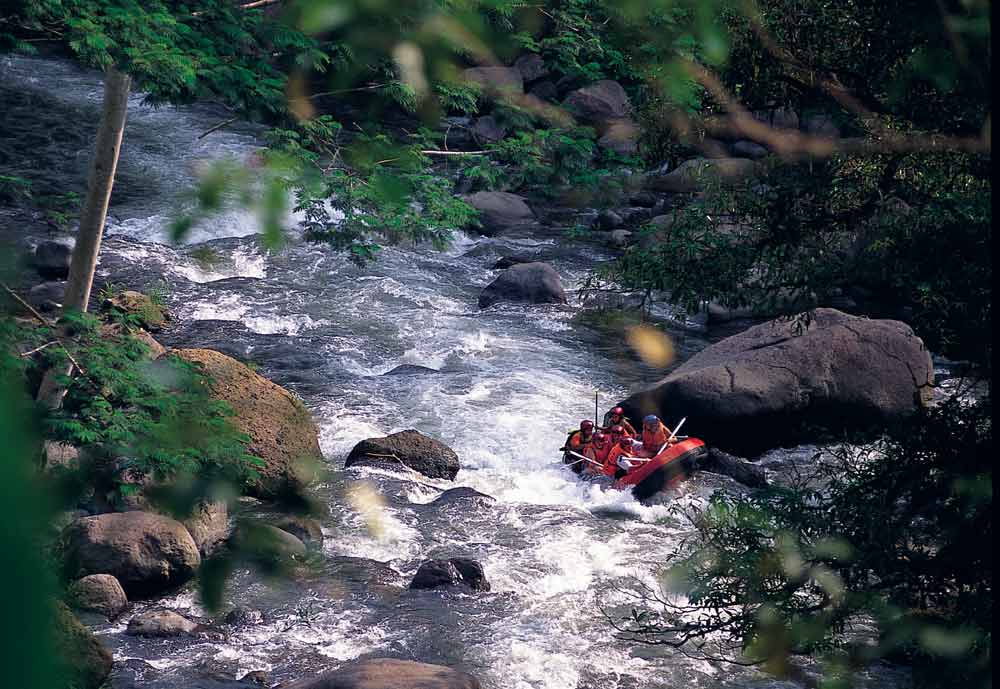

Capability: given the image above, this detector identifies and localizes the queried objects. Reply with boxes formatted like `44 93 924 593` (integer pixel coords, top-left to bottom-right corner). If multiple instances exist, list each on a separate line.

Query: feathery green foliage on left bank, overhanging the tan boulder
28 315 261 500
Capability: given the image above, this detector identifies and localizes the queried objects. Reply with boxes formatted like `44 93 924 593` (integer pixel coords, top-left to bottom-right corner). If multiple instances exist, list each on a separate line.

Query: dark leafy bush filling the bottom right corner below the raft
619 400 993 687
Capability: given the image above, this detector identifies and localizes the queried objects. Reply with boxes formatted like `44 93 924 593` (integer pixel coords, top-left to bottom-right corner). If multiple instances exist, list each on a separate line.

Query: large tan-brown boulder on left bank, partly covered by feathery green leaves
175 349 323 498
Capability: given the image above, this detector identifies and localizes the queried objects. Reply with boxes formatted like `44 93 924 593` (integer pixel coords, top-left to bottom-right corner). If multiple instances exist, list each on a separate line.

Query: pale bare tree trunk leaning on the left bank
38 67 130 409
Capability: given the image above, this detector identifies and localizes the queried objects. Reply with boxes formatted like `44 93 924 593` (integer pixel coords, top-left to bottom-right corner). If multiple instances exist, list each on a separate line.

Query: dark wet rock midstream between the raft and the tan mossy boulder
344 429 461 481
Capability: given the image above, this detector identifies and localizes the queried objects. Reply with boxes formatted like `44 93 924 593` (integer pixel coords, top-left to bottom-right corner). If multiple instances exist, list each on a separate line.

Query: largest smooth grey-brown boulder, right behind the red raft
622 308 934 456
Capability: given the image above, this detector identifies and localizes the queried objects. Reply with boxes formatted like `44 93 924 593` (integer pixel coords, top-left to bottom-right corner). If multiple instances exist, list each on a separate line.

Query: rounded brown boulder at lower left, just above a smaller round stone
61 512 201 596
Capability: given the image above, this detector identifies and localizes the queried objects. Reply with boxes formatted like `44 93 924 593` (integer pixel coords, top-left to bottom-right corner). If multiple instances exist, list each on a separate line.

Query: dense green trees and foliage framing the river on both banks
0 0 992 686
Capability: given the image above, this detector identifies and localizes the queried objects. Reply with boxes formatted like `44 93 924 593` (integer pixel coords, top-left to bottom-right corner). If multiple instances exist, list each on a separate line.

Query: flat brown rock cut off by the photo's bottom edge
281 658 481 689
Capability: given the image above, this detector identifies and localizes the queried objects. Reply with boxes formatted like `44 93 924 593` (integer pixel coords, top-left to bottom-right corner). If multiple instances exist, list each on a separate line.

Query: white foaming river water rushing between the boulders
0 58 901 689
